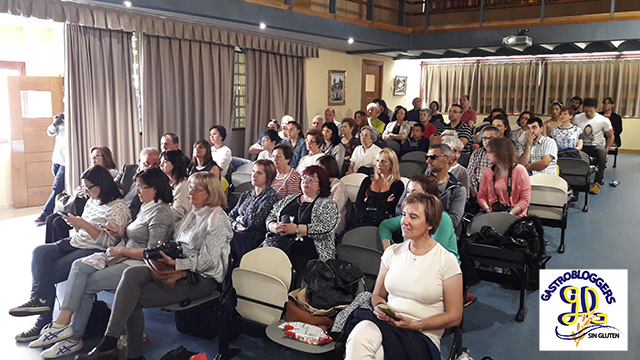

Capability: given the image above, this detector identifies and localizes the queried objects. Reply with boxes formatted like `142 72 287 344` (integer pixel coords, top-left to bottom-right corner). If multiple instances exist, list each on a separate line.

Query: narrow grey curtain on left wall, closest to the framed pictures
244 49 307 157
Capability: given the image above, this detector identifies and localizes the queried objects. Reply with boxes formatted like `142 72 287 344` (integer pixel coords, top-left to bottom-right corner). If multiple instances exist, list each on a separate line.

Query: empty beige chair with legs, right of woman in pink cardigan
528 174 569 254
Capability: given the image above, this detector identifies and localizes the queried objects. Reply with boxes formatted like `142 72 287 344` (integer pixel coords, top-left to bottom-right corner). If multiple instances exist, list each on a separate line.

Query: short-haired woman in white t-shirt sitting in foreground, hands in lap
345 194 463 360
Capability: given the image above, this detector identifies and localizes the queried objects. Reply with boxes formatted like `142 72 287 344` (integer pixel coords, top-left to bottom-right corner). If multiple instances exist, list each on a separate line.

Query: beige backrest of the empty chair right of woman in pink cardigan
527 184 567 220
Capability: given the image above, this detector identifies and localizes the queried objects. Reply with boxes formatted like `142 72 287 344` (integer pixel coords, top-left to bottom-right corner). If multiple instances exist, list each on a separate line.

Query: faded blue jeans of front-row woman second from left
60 259 134 338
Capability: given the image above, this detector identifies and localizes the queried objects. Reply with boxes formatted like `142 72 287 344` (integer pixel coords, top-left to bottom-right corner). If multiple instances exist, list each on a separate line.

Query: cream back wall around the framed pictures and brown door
305 49 420 127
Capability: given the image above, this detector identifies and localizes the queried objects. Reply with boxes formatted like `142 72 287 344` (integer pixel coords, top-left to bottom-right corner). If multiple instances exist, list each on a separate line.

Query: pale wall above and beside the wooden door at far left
0 19 64 209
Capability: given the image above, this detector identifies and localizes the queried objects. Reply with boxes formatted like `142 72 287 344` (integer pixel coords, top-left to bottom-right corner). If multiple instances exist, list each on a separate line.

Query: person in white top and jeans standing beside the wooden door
35 113 67 226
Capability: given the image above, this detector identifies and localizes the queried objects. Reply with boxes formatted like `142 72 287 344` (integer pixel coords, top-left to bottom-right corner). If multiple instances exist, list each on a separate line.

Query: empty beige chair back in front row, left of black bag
232 247 291 325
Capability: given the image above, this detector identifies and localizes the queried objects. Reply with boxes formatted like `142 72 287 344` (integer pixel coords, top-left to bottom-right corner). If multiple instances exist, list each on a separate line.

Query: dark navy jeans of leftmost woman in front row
31 239 100 328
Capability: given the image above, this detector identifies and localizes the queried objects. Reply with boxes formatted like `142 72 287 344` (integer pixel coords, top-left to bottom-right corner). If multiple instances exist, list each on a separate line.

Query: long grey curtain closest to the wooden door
65 24 140 188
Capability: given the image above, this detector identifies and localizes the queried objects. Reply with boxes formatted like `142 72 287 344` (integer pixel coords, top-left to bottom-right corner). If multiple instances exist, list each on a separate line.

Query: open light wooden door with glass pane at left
7 76 64 208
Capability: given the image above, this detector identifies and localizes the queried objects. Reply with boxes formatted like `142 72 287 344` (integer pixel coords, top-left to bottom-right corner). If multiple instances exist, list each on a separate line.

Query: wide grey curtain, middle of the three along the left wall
142 36 234 151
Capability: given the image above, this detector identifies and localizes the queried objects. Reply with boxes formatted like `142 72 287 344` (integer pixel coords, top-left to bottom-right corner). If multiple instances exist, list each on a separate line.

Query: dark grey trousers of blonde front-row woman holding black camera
105 266 218 358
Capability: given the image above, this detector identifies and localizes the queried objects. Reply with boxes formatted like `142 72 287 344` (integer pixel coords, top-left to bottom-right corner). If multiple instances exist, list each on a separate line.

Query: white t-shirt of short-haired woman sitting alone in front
382 241 462 349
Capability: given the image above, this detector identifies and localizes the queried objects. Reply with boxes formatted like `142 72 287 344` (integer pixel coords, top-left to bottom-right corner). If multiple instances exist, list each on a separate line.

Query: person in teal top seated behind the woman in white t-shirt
378 174 460 262
